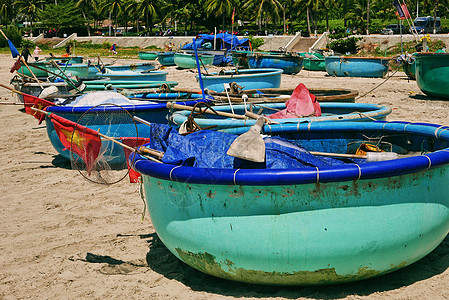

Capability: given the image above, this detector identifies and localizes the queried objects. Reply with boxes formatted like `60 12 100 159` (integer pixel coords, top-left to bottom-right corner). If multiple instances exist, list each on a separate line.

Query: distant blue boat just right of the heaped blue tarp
247 52 304 74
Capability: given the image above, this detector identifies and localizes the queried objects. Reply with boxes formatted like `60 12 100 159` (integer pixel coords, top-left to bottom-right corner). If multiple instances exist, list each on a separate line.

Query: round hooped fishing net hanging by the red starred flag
70 103 139 185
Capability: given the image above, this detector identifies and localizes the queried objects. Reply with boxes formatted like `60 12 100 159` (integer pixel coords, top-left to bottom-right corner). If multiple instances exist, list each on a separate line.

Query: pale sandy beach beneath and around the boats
0 55 449 299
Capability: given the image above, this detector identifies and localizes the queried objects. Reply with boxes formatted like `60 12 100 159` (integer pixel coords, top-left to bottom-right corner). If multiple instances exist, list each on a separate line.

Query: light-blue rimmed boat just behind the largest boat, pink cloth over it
170 103 392 130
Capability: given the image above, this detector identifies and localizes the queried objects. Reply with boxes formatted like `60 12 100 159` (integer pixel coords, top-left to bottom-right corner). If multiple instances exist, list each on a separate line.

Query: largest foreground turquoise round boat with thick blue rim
133 122 449 285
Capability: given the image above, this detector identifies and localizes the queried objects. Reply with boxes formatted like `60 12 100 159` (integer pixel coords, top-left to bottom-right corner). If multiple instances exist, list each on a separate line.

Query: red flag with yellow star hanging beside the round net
49 114 101 174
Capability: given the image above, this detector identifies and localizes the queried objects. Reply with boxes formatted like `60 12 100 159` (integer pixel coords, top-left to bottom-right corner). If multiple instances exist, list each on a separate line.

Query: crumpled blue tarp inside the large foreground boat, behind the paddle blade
147 123 360 169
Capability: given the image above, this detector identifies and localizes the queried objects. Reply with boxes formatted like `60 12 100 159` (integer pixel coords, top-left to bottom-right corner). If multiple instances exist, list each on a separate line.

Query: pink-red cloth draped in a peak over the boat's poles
268 83 321 119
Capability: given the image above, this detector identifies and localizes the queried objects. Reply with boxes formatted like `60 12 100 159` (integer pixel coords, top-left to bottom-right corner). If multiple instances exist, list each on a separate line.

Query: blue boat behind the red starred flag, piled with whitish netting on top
46 98 207 165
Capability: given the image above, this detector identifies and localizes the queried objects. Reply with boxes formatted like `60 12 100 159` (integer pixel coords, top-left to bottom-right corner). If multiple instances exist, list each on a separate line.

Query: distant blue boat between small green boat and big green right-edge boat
325 56 389 78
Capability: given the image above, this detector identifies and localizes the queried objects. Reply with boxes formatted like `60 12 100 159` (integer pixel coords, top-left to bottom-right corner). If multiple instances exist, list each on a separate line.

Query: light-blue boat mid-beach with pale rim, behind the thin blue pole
196 69 283 93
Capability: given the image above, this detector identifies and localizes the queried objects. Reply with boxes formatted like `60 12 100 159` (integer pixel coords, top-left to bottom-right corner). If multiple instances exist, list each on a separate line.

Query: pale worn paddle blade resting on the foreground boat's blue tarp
226 118 265 163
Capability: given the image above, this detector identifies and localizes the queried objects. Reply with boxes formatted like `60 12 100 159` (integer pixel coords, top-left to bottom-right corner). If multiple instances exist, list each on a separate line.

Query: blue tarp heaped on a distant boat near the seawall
182 33 249 50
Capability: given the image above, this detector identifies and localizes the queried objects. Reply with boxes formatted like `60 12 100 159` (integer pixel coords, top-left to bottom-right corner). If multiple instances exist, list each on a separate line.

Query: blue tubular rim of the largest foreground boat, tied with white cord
129 121 449 186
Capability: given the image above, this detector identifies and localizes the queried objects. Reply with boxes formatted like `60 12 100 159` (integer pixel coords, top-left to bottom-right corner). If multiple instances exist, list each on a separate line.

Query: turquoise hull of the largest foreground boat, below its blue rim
143 167 449 285
